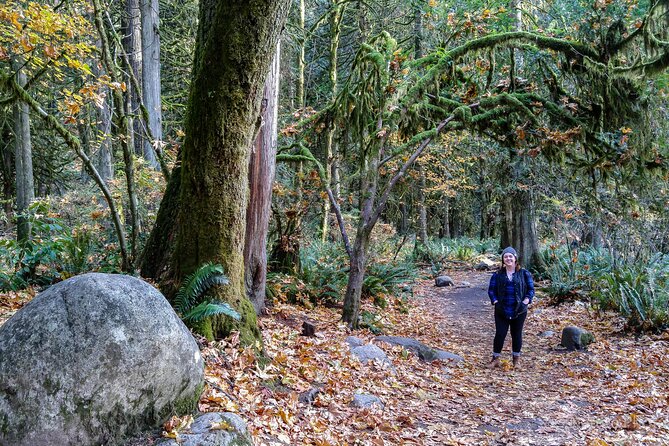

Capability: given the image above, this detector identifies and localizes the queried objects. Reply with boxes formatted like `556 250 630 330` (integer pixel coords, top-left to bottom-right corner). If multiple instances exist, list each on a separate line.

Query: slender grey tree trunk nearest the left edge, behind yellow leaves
14 64 35 242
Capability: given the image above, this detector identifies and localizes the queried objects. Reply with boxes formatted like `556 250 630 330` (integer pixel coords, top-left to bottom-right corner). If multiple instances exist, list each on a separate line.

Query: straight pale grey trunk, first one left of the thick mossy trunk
140 0 163 170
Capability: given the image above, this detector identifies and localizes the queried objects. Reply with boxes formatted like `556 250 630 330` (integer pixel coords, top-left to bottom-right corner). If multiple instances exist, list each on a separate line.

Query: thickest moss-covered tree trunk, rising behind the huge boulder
144 0 290 345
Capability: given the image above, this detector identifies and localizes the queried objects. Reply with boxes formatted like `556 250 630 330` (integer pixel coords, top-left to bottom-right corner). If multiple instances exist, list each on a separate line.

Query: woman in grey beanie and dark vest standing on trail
488 246 534 367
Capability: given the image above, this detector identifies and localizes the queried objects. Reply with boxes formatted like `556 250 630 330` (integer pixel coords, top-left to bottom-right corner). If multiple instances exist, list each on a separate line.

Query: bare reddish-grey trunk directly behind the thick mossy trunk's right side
244 42 281 314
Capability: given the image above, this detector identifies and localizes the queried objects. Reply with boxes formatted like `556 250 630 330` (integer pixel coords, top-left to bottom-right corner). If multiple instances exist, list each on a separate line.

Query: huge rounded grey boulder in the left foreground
0 274 204 446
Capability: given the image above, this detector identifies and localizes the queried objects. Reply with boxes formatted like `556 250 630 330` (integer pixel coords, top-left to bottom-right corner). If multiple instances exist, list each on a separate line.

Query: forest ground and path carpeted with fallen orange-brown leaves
0 270 669 446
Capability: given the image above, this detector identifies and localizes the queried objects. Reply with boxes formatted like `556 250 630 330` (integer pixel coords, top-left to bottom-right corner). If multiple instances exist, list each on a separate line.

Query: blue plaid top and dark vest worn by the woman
488 269 534 319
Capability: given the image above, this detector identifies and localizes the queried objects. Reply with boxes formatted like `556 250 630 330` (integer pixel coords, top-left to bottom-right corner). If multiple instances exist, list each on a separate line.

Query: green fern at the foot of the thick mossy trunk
174 263 241 322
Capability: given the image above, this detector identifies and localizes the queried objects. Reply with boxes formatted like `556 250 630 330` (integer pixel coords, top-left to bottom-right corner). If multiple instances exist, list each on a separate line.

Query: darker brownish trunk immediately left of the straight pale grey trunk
122 0 144 159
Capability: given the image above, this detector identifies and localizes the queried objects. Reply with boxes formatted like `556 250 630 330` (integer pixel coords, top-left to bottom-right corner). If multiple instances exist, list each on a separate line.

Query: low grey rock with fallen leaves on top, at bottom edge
156 412 253 446
